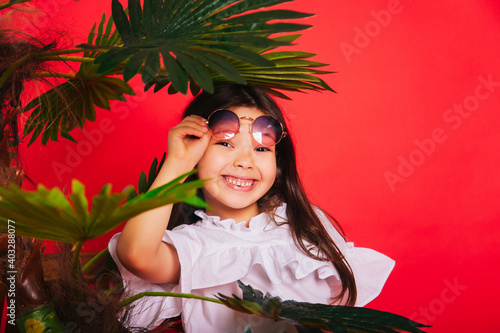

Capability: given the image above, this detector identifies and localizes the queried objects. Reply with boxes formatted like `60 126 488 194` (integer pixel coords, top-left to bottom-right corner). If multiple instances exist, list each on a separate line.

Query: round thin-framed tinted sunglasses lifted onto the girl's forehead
205 110 286 146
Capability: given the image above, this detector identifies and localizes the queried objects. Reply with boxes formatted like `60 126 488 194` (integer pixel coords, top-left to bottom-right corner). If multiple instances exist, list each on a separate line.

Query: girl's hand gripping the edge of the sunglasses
166 115 211 173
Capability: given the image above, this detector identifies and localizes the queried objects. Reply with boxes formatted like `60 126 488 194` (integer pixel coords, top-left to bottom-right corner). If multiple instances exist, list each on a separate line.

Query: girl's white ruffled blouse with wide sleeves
109 204 395 333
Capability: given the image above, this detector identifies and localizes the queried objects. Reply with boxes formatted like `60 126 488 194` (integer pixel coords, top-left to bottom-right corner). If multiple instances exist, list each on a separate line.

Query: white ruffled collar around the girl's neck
195 203 288 232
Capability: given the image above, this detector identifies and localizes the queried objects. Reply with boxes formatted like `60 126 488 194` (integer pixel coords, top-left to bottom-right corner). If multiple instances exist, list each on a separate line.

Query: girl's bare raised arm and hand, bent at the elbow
116 116 212 283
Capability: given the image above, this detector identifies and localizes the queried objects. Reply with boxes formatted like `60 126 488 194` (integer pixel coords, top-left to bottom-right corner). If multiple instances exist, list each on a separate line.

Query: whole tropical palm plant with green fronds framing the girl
0 0 430 332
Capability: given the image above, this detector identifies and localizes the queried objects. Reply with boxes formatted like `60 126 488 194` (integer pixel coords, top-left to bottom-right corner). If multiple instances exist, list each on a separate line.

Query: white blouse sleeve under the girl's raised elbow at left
108 233 182 328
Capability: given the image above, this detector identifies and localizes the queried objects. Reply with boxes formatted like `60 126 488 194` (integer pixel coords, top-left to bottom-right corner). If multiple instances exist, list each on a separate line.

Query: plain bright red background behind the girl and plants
13 0 500 332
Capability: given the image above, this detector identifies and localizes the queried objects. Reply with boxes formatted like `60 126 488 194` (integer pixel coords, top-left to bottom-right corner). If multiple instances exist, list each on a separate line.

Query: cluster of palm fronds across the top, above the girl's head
0 0 332 148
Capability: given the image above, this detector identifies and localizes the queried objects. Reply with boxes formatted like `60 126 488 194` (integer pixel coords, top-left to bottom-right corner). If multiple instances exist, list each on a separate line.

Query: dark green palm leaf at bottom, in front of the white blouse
217 281 428 333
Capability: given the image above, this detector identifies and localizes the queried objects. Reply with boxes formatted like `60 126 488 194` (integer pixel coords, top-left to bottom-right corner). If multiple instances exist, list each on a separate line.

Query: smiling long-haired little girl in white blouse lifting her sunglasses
109 84 394 333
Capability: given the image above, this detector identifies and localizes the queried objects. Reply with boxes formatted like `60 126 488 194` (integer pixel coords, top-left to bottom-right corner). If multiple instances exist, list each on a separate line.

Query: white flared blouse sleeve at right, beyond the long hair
316 208 395 306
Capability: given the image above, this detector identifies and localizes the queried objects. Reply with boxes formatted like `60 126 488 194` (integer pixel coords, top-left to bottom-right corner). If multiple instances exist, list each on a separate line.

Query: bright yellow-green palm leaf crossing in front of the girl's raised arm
0 173 205 243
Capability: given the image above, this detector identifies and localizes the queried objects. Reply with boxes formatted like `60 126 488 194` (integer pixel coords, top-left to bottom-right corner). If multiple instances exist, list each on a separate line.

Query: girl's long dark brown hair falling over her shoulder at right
168 84 357 305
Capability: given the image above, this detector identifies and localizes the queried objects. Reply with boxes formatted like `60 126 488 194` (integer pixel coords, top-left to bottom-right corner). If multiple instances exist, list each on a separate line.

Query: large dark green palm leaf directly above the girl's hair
95 0 310 94
